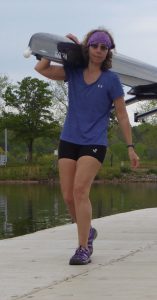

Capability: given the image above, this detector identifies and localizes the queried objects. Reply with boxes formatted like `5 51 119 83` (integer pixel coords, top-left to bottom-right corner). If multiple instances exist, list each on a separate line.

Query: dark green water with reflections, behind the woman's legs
0 183 157 239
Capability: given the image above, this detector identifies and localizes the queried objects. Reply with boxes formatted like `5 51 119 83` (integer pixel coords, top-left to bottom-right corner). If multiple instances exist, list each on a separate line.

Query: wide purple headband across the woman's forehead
87 31 112 49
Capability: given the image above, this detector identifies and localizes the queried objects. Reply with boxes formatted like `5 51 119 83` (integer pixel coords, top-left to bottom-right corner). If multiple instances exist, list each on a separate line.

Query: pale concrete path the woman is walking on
0 208 157 300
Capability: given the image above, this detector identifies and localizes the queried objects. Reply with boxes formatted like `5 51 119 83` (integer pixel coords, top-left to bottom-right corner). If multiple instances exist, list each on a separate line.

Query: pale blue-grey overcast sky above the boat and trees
0 0 157 124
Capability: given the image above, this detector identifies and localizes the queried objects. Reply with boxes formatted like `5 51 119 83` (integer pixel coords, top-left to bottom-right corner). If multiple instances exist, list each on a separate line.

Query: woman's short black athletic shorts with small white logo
58 140 107 163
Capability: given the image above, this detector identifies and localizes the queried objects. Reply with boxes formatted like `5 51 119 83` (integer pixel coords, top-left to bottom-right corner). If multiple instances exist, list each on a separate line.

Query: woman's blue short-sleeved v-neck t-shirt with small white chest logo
61 68 124 146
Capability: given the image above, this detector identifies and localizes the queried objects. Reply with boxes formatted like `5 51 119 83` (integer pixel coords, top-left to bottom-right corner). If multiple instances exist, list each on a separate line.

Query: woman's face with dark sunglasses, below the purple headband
89 44 108 65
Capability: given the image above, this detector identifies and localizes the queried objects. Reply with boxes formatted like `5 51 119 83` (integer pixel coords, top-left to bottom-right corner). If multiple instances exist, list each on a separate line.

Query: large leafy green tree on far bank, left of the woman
0 77 60 162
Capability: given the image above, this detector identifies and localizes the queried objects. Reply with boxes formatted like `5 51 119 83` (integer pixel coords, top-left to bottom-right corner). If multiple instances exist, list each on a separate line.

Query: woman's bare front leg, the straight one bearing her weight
73 156 101 248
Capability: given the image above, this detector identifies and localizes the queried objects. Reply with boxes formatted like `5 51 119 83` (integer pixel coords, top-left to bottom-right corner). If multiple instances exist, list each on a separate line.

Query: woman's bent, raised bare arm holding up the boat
34 58 65 80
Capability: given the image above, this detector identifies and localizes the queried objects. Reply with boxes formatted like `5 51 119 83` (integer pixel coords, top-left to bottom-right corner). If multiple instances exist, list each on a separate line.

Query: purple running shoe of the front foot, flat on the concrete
69 246 91 265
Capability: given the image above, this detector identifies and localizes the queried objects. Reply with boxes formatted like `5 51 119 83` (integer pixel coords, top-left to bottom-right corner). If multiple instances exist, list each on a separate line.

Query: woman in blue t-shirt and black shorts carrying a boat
35 29 139 265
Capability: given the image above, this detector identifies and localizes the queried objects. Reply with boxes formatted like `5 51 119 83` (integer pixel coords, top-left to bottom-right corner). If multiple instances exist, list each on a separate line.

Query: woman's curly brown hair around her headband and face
82 29 115 71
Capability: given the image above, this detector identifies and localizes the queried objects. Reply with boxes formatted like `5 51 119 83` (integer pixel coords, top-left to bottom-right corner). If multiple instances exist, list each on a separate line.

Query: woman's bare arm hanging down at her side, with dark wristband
114 97 139 168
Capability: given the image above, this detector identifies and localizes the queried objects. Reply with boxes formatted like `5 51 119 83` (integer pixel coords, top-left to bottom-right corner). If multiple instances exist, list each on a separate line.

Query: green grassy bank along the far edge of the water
0 162 157 181
